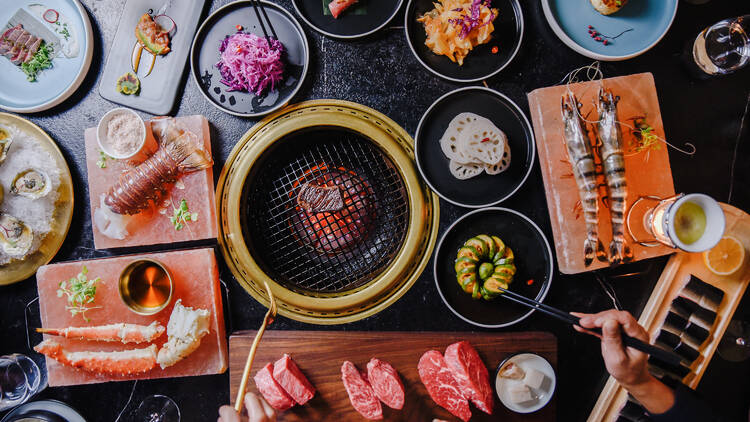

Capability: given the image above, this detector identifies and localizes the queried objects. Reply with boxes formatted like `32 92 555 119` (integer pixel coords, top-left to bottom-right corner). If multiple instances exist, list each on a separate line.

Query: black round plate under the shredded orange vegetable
404 0 524 82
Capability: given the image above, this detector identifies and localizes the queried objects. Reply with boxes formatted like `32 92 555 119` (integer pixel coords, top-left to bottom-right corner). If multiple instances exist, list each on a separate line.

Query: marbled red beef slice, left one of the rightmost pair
417 350 471 421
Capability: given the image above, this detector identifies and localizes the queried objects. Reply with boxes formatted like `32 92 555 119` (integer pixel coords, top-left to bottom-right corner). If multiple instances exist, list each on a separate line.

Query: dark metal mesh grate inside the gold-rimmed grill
244 129 409 294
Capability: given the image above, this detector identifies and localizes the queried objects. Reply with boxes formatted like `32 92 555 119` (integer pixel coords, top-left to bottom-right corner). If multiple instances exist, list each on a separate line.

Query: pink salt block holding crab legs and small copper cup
37 248 227 387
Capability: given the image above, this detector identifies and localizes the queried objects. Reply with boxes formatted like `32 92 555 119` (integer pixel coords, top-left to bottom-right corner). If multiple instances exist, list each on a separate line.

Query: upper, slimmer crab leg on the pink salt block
36 321 165 344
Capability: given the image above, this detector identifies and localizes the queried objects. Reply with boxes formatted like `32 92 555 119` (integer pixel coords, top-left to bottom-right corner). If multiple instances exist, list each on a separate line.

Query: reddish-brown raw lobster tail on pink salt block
104 118 213 215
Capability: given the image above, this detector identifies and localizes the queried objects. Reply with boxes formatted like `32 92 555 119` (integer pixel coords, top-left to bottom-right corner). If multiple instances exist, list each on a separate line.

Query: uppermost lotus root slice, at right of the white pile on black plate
459 115 508 164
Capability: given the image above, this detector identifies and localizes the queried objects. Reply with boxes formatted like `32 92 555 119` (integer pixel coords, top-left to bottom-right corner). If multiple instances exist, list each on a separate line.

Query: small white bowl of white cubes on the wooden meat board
495 353 557 413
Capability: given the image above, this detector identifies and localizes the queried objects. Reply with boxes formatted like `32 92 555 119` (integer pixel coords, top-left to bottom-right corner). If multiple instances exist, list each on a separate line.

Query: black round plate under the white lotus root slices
414 87 536 208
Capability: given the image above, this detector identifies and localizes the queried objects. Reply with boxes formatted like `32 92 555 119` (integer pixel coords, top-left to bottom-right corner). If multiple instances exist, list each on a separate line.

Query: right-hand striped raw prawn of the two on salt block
597 88 633 264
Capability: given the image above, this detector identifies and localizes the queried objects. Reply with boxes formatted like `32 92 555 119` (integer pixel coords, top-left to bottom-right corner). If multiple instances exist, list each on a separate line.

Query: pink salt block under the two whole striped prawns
528 73 677 274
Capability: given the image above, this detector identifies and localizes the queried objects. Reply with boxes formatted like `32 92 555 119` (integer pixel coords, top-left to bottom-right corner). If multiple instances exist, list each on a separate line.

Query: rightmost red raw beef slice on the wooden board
445 341 495 415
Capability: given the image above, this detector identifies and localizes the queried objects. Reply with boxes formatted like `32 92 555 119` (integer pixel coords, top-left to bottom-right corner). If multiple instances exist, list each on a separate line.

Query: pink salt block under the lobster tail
84 115 219 249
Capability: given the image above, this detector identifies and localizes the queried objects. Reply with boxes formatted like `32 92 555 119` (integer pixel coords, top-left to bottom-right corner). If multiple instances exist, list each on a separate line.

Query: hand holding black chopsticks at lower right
573 309 652 389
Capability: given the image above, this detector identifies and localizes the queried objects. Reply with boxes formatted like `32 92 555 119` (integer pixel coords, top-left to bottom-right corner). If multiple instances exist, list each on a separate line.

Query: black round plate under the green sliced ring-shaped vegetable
434 208 552 328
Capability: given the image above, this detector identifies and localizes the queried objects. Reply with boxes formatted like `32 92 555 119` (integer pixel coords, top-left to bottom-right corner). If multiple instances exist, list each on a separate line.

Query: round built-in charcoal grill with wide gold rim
216 100 439 324
